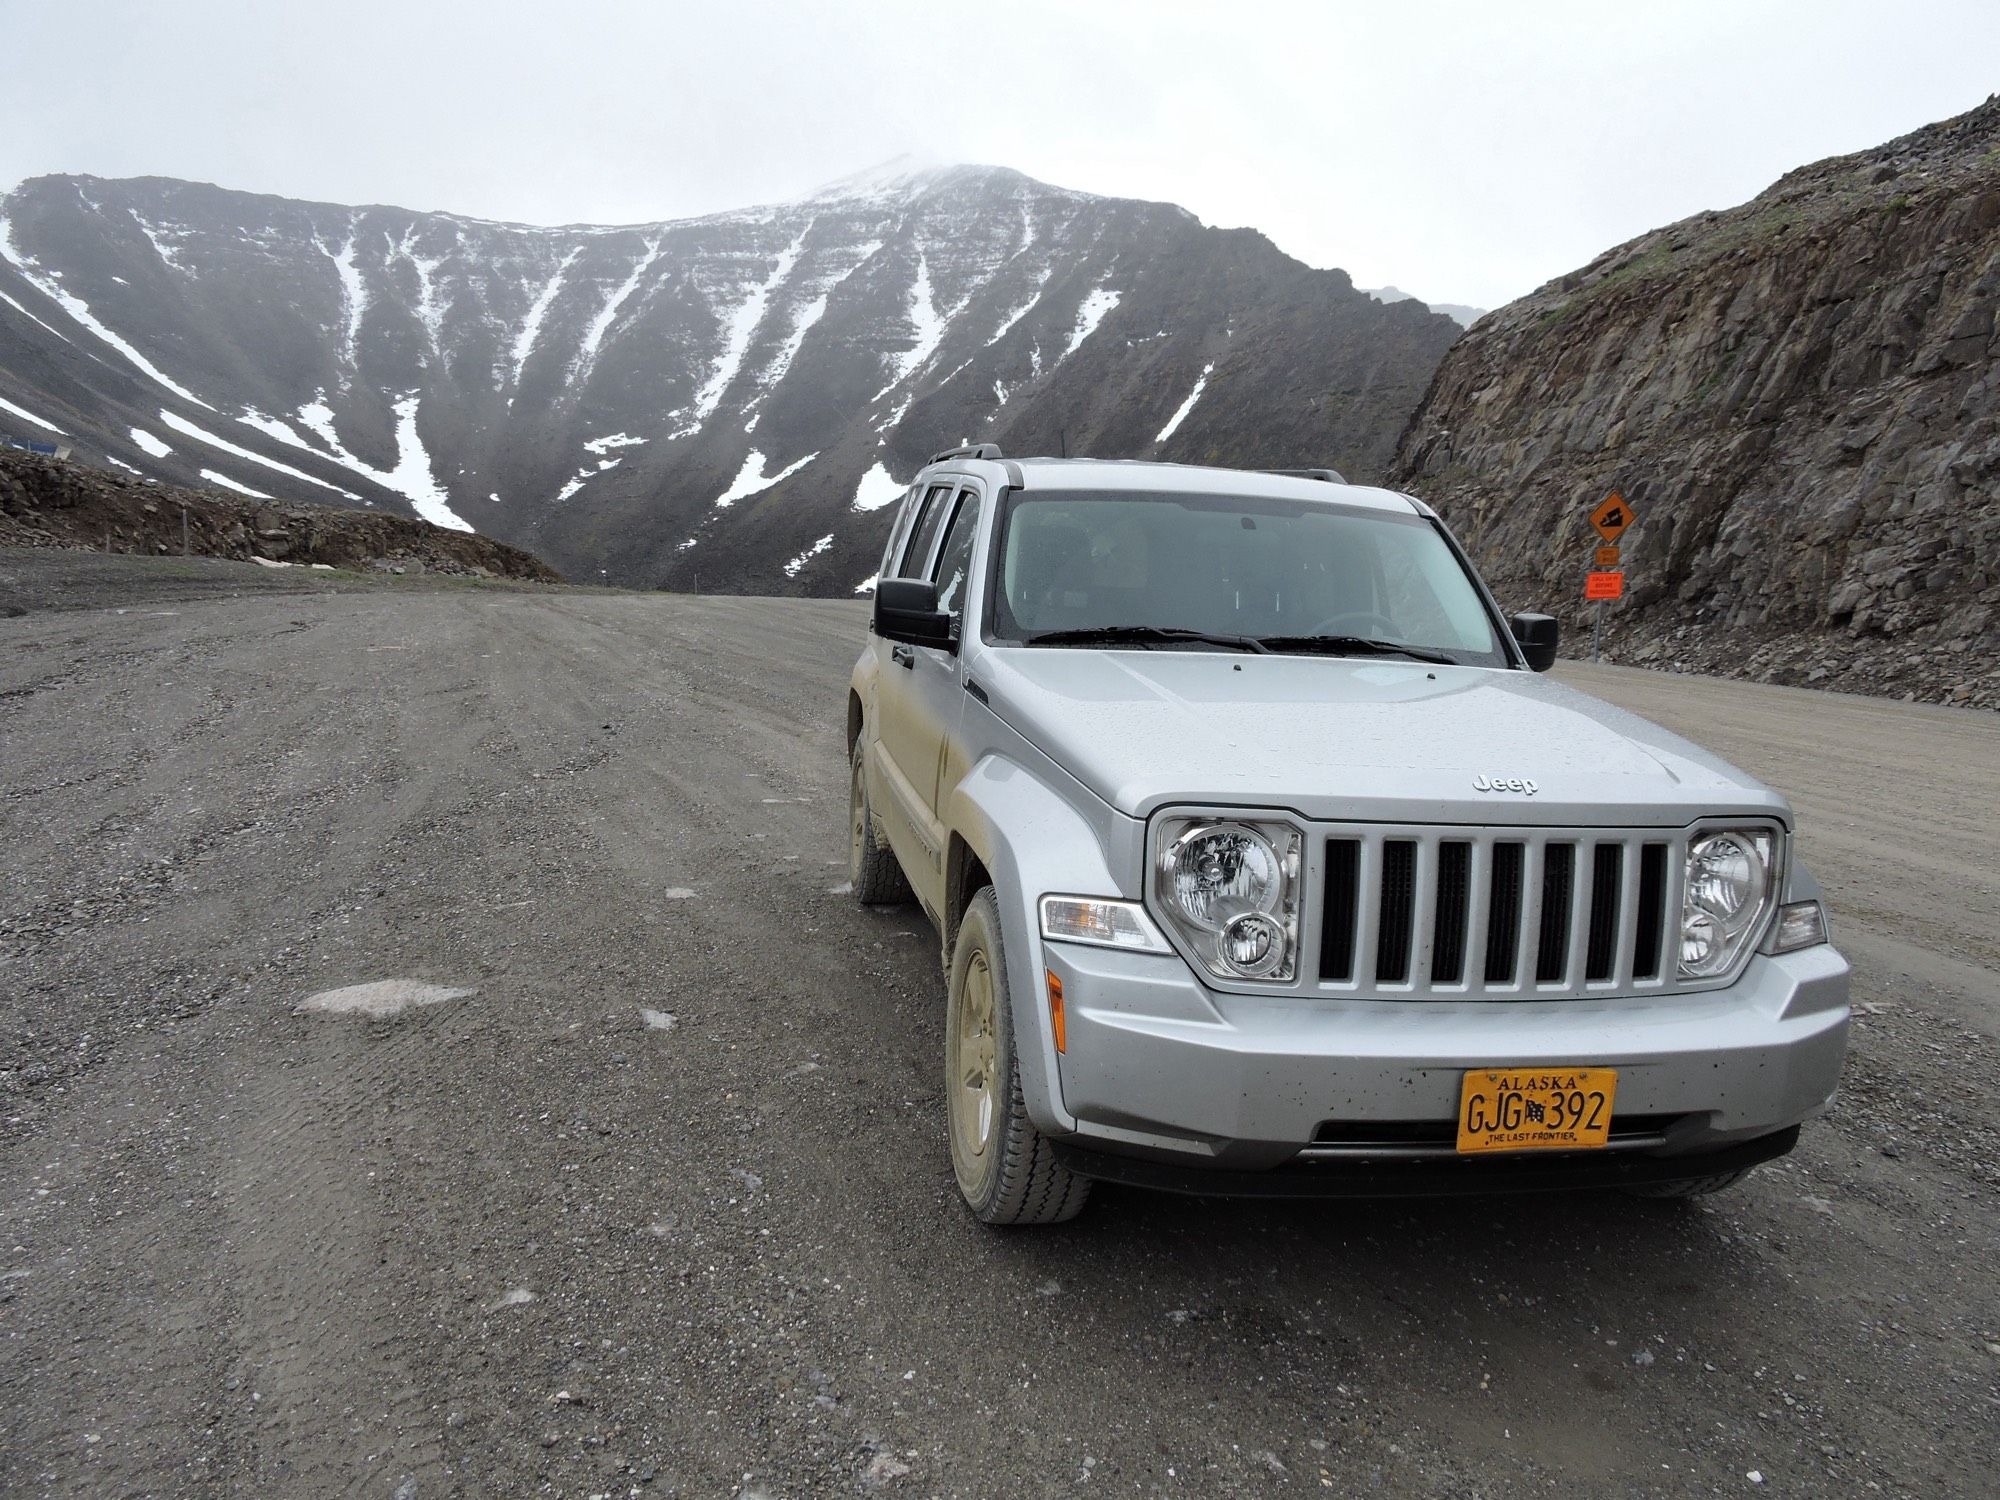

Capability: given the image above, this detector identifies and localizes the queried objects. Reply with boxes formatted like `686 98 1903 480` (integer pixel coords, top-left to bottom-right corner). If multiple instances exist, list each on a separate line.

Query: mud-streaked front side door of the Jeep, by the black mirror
876 482 980 910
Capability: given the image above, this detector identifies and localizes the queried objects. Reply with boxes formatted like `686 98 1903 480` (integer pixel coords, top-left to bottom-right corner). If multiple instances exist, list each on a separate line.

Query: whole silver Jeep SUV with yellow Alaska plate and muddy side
848 444 1848 1224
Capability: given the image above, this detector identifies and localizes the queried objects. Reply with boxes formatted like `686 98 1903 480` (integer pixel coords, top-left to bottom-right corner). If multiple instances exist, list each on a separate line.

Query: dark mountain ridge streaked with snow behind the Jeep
0 164 1458 594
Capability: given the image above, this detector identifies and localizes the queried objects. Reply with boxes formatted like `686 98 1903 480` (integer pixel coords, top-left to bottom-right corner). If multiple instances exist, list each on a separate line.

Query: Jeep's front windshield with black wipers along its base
994 490 1508 666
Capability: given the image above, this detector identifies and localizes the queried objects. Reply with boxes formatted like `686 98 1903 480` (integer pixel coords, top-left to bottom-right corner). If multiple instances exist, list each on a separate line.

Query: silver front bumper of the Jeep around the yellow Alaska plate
1042 944 1848 1192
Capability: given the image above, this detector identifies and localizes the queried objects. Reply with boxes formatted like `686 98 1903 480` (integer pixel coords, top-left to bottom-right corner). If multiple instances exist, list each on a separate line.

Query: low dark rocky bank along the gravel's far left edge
0 448 560 582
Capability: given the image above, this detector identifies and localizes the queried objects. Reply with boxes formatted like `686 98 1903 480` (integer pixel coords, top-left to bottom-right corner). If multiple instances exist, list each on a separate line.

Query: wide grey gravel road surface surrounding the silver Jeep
0 552 2000 1500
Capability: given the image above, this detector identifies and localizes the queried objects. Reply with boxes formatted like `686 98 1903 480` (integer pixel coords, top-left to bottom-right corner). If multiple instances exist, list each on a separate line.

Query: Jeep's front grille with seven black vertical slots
1316 826 1678 998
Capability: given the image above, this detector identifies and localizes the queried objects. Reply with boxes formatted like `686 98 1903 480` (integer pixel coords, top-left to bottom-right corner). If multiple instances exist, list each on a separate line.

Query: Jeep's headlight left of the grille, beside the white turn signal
1154 818 1304 980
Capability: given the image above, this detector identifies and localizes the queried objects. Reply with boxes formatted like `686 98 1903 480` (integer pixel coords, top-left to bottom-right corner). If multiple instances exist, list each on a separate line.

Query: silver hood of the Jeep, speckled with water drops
976 648 1790 826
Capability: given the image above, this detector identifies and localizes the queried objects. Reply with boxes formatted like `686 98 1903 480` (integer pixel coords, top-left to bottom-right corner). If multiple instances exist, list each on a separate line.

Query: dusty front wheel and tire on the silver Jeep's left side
944 886 1090 1224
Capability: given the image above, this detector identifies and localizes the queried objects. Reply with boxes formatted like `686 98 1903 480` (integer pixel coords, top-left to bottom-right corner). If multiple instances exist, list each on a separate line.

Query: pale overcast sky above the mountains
0 0 2000 306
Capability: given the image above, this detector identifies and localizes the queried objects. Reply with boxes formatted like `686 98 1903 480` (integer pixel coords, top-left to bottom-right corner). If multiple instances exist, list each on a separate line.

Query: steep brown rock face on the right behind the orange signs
1390 100 2000 708
